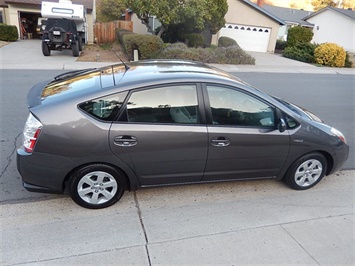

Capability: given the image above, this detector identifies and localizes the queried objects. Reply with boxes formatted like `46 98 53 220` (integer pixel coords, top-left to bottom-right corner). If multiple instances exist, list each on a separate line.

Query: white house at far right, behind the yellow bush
304 6 355 53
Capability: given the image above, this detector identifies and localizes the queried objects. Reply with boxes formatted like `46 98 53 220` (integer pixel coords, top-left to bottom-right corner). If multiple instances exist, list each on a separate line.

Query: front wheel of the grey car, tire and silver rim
285 153 327 190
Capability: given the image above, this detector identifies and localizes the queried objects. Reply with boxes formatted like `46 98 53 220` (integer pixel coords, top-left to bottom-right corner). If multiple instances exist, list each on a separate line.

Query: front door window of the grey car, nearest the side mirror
207 85 276 127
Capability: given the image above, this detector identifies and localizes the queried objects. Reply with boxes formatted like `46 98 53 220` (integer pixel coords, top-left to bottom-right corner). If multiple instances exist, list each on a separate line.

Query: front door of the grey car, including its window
203 84 289 181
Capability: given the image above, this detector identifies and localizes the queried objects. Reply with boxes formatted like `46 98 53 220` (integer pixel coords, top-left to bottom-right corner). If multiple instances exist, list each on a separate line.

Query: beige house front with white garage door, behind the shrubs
212 0 286 53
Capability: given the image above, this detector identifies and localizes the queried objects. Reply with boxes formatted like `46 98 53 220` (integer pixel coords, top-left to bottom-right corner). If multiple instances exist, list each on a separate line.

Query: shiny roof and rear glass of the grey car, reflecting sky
36 60 251 106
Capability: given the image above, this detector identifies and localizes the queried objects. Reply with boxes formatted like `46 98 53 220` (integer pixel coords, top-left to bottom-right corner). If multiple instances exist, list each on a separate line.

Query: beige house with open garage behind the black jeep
0 0 96 44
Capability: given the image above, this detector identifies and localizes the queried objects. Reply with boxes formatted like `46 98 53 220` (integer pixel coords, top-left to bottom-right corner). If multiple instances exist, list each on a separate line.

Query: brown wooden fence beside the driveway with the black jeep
94 20 133 44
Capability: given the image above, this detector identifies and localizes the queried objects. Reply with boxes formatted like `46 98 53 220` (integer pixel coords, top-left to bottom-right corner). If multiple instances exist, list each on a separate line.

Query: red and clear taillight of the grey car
23 113 43 153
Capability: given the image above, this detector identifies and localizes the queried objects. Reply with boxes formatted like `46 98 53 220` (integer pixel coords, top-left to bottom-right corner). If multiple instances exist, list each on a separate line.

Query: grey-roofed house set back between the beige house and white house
262 5 314 41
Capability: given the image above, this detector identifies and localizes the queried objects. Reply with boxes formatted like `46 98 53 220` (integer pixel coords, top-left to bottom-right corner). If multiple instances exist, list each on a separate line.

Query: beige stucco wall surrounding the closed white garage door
212 0 280 53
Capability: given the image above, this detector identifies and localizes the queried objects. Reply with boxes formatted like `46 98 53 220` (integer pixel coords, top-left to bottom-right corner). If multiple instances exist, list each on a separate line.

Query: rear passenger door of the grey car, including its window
109 84 207 186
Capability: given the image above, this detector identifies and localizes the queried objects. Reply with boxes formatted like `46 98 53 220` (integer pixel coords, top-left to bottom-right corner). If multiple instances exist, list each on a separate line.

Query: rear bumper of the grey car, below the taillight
17 149 77 193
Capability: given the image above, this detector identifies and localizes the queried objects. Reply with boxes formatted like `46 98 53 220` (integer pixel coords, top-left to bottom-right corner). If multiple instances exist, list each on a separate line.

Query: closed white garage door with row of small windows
219 24 271 52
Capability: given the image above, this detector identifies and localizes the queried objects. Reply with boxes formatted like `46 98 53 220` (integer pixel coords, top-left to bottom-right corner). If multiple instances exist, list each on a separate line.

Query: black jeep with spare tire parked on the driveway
42 18 82 57
